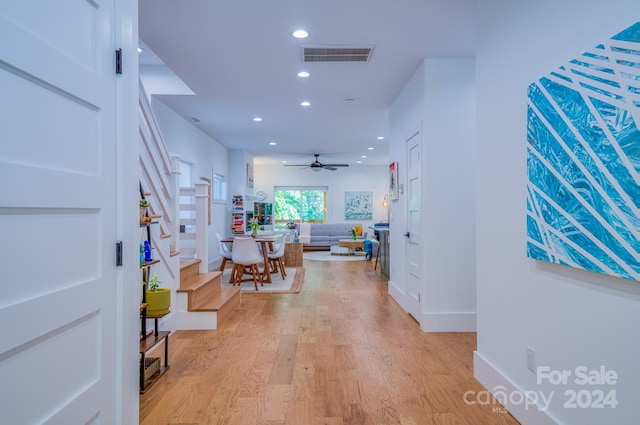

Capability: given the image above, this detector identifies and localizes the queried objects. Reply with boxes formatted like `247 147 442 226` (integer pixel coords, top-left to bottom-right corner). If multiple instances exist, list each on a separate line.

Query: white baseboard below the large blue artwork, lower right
476 351 559 425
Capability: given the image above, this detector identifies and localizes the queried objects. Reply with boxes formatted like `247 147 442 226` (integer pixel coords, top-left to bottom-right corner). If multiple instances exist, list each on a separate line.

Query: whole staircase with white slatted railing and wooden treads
139 83 240 331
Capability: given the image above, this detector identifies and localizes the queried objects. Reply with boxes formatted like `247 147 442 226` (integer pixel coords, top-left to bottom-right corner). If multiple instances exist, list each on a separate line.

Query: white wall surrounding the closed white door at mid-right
389 58 476 331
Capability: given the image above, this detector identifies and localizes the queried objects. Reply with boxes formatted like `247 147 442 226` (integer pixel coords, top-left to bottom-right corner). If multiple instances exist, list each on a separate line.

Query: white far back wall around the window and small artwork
254 164 388 230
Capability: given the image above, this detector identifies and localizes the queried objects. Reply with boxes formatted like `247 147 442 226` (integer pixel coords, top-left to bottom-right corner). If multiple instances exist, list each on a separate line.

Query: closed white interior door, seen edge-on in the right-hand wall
405 130 423 322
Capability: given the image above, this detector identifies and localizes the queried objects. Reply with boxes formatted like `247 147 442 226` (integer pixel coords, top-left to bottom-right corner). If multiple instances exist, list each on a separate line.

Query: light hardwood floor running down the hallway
140 261 518 425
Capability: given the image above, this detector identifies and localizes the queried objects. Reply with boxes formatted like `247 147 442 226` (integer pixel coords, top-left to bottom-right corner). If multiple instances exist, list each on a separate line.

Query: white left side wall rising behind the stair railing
151 97 229 268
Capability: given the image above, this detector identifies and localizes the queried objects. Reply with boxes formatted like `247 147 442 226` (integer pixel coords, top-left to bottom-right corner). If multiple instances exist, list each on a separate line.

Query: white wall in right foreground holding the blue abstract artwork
475 0 640 424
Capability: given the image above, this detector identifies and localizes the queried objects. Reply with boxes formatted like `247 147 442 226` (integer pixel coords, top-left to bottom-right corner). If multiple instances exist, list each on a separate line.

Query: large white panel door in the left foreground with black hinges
0 0 117 425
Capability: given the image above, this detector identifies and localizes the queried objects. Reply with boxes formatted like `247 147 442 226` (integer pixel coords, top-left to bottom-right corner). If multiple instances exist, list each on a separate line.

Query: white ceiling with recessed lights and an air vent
139 0 475 165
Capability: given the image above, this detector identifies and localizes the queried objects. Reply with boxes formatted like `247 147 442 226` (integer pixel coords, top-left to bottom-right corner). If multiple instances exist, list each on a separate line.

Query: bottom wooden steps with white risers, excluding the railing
177 259 240 330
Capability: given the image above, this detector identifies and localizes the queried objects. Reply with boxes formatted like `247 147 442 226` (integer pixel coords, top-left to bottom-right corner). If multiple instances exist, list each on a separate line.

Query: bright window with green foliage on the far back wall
273 186 327 229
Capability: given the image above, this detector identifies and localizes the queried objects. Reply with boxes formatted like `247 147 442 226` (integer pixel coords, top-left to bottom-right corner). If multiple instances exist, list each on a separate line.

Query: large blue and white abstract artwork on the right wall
527 22 640 281
